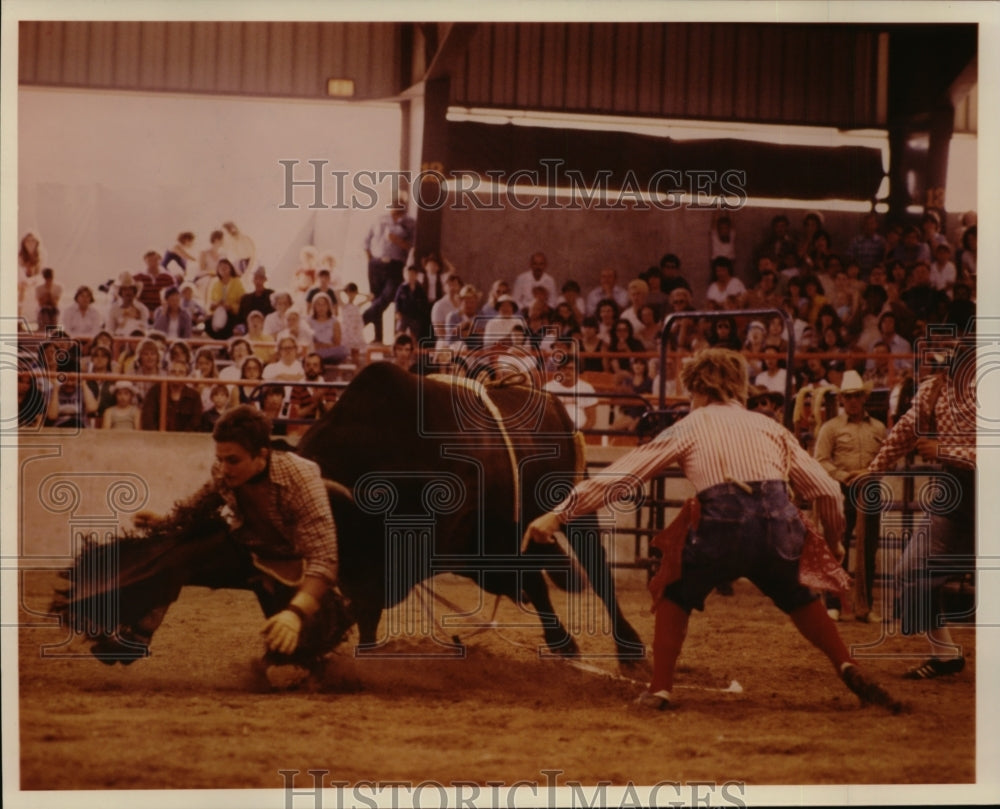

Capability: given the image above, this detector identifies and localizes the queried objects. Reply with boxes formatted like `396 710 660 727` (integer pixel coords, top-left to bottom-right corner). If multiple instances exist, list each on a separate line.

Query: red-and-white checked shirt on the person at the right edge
868 374 976 472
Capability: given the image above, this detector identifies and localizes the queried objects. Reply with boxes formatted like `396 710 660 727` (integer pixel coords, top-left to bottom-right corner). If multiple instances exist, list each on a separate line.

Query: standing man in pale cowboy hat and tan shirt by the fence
813 369 886 623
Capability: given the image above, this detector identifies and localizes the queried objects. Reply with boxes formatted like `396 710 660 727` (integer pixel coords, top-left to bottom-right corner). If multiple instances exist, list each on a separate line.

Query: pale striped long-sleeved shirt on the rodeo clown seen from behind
555 402 843 531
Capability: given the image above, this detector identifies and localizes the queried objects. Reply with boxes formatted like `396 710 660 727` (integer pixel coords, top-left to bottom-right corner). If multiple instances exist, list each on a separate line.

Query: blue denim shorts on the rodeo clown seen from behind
663 480 816 613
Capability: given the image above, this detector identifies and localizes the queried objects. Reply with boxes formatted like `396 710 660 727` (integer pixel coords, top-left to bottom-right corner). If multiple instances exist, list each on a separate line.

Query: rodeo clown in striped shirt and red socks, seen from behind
525 348 903 713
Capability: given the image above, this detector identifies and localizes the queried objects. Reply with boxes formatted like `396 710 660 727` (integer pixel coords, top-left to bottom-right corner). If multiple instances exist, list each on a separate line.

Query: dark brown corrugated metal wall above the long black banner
452 23 885 127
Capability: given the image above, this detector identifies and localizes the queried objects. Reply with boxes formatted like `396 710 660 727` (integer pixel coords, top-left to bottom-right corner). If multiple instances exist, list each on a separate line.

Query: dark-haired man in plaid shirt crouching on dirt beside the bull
74 405 349 688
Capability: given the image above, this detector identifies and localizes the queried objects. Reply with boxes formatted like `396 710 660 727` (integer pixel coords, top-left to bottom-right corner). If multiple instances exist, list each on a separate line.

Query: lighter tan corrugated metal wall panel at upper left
19 22 402 98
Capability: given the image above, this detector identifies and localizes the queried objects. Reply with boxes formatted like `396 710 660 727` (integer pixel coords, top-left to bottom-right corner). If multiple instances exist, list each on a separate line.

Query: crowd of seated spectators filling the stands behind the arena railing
18 204 976 443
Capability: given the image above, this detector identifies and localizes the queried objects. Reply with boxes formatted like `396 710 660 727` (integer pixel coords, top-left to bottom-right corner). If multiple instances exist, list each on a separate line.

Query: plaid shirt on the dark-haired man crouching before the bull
213 452 337 583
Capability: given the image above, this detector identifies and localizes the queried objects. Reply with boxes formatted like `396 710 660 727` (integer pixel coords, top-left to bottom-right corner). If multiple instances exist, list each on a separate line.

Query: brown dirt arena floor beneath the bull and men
13 571 976 790
